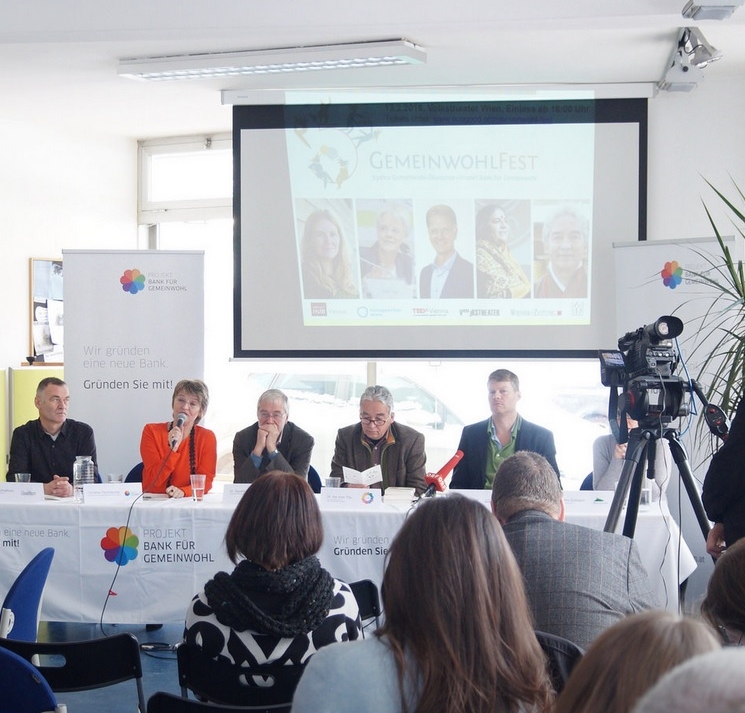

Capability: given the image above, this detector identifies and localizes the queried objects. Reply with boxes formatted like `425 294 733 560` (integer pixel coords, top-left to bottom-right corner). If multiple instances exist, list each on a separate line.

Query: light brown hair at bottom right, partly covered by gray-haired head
555 610 719 713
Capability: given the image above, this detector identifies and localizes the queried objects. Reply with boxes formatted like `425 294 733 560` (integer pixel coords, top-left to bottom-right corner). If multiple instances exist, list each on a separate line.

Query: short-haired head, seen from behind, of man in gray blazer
491 451 561 522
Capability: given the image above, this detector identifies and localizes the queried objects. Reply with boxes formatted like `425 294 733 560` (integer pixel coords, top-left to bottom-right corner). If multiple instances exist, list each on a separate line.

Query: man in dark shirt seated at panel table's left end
7 376 100 497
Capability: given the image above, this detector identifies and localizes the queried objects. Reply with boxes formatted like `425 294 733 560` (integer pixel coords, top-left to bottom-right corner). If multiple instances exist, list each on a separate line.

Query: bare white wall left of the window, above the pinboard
0 119 137 368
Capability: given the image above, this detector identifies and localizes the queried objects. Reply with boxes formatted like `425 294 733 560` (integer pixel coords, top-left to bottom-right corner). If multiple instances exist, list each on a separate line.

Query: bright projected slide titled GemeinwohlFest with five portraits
286 124 595 326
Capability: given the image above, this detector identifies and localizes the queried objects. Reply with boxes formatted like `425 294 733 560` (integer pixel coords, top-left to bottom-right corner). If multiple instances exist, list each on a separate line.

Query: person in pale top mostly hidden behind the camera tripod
592 415 673 500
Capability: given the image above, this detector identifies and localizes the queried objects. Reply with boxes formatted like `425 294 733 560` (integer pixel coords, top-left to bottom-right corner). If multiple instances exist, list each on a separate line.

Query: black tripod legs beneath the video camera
604 425 711 540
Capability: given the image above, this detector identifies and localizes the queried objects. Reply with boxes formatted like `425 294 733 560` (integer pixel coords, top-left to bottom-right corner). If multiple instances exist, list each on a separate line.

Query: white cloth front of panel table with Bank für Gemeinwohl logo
0 492 696 624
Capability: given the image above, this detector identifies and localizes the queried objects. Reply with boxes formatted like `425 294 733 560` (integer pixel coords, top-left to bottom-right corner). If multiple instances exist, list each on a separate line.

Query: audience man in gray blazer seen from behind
492 451 658 649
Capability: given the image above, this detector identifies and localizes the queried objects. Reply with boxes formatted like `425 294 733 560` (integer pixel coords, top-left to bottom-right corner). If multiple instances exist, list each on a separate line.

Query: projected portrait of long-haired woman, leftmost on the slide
300 210 359 300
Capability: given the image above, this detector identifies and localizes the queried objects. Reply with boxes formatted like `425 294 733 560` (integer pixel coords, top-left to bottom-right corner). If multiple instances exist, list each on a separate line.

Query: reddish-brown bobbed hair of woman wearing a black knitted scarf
225 470 323 570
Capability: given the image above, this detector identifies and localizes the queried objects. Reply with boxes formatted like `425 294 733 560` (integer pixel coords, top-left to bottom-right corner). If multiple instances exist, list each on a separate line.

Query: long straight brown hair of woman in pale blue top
377 495 552 713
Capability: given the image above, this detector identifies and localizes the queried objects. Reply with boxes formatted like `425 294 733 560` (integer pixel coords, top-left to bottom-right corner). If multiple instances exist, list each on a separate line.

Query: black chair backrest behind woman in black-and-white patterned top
176 642 305 711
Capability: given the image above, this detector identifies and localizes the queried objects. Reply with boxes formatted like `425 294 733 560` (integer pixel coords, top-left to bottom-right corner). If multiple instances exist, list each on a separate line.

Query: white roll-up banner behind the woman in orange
63 250 204 479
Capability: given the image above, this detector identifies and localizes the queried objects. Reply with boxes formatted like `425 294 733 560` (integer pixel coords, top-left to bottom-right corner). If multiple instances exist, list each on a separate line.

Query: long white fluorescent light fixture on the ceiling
118 39 427 81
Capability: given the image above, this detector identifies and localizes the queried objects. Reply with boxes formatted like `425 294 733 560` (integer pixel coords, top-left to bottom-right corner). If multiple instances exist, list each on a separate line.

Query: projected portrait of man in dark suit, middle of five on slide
419 205 473 299
